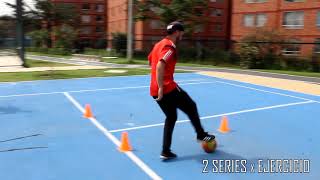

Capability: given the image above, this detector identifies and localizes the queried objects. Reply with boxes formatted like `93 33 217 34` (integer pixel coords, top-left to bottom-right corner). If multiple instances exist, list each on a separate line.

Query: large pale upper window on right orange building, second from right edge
283 11 304 29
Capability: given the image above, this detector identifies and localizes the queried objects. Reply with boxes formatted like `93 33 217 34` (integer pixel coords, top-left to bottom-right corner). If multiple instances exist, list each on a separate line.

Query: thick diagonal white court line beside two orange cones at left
63 92 162 179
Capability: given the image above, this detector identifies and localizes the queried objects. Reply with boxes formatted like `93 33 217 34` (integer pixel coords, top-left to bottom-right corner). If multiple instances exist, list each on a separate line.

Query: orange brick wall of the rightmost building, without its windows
231 0 320 56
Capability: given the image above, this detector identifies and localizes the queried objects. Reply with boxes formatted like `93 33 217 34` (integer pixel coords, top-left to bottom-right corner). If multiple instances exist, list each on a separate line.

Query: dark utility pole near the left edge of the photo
16 0 25 65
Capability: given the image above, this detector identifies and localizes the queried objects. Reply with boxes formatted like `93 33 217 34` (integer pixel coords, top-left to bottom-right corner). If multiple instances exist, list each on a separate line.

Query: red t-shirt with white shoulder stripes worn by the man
148 38 177 96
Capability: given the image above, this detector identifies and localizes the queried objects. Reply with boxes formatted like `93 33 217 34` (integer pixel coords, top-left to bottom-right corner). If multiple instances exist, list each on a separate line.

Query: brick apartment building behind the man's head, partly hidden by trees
107 0 230 49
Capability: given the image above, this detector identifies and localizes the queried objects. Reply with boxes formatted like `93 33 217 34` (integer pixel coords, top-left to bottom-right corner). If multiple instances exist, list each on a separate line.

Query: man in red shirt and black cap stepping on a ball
148 21 215 159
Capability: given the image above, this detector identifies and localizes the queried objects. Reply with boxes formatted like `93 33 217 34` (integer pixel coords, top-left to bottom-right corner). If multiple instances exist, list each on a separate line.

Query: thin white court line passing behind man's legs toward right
109 100 315 133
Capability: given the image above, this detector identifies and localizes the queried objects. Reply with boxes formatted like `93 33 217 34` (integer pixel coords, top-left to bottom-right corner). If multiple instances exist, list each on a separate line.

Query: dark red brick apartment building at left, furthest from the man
52 0 107 47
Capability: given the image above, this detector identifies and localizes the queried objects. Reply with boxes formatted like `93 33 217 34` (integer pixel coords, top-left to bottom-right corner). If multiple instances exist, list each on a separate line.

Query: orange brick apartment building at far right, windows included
231 0 320 56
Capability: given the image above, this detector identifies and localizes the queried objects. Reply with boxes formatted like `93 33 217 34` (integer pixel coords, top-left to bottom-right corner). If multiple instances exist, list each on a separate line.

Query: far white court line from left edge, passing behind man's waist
0 81 216 98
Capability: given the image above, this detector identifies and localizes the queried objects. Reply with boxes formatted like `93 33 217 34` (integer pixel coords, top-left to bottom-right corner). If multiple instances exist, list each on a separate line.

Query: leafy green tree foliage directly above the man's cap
135 0 209 33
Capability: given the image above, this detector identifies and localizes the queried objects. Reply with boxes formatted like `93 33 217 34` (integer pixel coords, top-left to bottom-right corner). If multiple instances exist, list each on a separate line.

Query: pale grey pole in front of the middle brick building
127 0 133 61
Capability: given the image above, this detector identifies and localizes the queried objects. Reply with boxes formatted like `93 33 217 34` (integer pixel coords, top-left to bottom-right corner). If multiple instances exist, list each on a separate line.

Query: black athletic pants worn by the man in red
153 87 204 152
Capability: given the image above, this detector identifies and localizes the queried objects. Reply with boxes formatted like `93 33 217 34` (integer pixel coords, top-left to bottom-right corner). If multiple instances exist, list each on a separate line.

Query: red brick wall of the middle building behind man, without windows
106 0 230 49
